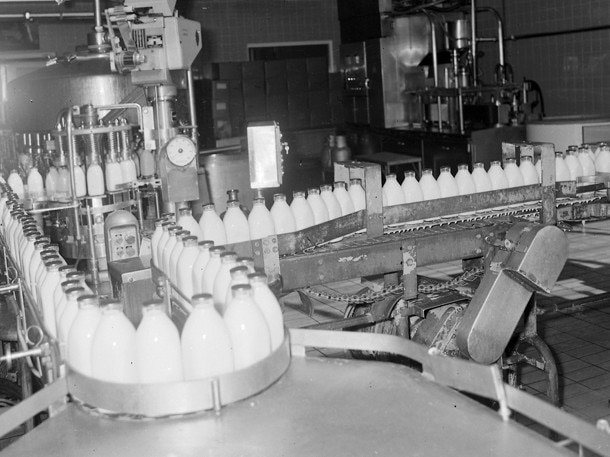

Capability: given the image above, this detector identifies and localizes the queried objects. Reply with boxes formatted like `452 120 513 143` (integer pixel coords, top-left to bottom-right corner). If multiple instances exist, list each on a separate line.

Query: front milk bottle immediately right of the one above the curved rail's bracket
224 285 271 370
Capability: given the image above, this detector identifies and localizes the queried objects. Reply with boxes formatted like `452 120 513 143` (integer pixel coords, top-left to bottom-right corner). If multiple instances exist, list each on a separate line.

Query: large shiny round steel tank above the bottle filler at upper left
7 58 136 131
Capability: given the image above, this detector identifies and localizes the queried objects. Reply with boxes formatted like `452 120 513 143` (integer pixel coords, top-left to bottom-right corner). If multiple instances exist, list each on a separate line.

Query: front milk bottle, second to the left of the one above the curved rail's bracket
91 302 138 384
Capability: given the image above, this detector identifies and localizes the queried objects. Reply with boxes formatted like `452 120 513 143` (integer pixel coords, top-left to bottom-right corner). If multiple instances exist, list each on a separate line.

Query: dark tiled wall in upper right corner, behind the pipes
479 0 610 116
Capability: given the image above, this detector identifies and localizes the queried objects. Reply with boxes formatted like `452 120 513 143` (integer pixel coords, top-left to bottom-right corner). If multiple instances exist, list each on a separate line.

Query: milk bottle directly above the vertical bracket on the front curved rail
181 294 233 381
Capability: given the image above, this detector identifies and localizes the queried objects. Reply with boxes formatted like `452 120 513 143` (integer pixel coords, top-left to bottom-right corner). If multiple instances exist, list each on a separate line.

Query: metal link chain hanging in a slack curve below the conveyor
300 268 484 305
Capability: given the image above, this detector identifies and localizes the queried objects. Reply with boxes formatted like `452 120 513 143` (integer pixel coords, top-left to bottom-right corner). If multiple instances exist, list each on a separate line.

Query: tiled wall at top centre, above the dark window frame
183 0 340 67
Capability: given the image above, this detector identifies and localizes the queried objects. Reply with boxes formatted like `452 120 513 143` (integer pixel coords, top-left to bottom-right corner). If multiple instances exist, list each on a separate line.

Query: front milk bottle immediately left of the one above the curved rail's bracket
136 300 183 383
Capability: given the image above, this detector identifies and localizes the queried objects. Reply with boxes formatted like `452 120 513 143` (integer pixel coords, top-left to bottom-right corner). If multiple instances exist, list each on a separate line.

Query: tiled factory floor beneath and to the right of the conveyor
284 221 610 432
